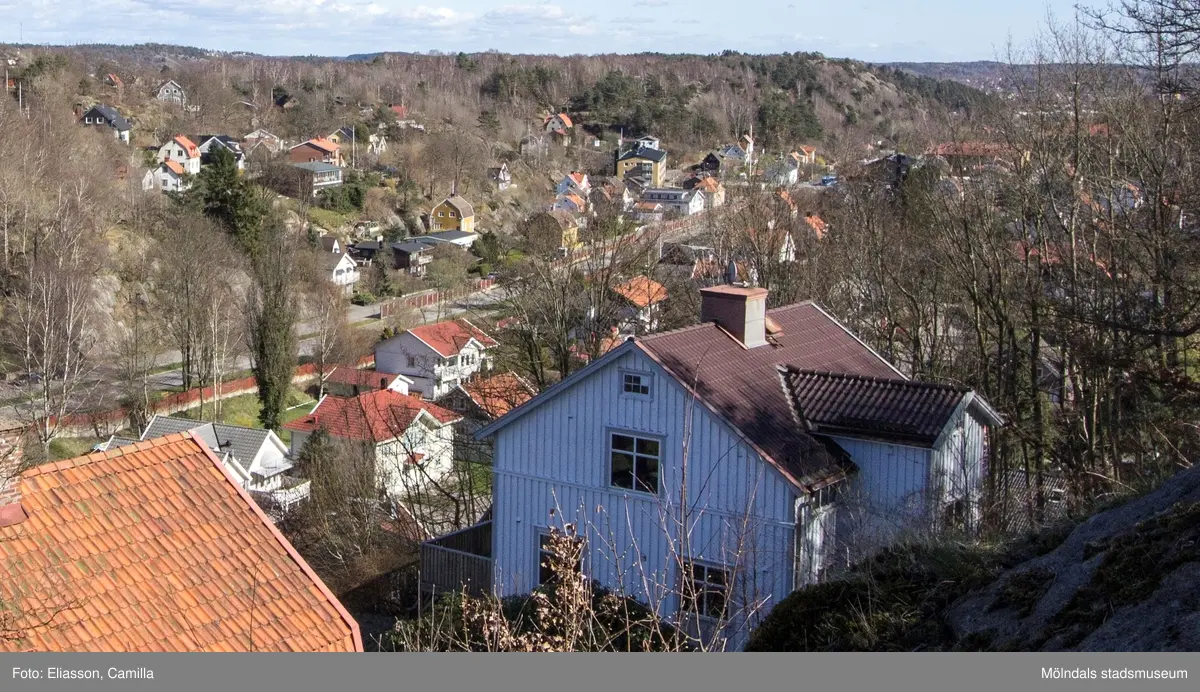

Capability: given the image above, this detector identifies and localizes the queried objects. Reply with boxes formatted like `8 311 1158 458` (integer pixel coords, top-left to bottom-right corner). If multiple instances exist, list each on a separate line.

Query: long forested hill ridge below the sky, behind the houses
0 44 986 154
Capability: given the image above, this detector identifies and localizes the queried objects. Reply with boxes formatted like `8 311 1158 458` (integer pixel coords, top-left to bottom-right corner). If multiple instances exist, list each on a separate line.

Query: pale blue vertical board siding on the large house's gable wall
493 350 797 638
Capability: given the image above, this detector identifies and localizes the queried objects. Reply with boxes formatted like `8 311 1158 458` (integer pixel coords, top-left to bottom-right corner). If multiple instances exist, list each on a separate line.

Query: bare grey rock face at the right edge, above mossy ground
946 468 1200 651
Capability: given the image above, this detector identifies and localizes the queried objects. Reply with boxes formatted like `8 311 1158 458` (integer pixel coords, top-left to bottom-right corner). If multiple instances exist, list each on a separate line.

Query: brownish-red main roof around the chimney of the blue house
637 301 904 487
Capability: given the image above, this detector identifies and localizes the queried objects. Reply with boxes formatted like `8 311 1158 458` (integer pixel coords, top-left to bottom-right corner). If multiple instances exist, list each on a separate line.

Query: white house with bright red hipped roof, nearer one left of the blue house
283 390 461 497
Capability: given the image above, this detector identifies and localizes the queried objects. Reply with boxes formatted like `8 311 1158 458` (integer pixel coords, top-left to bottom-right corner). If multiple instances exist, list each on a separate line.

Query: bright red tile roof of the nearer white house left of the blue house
283 390 462 444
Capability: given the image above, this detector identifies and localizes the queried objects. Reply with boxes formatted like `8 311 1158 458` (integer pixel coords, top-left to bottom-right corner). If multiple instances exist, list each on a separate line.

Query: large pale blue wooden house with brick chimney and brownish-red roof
421 284 1002 648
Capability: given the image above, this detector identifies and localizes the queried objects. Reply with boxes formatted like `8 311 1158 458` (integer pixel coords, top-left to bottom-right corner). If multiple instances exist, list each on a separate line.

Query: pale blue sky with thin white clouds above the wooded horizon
0 0 1086 62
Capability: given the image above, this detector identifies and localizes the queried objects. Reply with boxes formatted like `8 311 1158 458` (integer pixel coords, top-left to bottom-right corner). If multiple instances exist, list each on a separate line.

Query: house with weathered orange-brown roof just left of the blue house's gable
438 373 538 464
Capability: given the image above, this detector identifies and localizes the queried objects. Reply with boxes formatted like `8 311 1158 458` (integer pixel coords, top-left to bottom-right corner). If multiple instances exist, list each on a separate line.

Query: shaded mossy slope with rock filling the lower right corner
750 469 1200 651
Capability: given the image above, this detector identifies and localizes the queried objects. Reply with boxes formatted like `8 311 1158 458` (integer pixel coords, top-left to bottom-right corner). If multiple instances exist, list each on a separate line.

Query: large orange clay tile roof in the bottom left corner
0 434 362 651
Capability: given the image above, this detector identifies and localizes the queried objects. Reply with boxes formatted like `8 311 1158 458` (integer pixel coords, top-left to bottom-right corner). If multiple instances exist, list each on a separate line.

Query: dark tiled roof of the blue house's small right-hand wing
781 367 968 445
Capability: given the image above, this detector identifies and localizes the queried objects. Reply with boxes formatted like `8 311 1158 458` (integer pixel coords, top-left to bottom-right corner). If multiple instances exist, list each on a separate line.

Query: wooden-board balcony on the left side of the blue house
421 522 493 596
